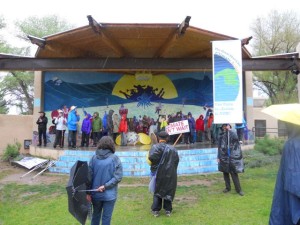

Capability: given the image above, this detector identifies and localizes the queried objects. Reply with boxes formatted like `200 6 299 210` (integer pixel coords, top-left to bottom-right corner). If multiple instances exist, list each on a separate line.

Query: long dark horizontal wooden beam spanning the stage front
0 57 300 72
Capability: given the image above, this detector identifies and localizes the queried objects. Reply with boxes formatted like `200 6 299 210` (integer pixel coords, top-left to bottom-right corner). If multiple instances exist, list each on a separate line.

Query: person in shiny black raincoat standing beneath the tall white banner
218 124 244 196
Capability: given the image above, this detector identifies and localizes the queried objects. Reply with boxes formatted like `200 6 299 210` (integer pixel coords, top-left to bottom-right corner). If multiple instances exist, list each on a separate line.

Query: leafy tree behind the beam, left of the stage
0 15 73 114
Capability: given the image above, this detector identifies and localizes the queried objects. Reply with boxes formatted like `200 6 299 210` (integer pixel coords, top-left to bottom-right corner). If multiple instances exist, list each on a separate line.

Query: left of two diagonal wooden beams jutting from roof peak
87 15 126 57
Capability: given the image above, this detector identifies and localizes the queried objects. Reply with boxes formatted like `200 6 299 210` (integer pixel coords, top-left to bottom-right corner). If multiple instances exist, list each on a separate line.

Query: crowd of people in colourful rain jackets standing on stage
37 104 246 148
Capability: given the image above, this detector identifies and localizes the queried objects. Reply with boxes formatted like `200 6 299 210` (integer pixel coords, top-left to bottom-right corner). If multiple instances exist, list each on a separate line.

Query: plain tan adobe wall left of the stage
0 115 33 155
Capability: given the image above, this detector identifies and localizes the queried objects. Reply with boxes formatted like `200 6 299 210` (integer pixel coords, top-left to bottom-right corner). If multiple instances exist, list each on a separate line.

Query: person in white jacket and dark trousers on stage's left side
53 110 67 148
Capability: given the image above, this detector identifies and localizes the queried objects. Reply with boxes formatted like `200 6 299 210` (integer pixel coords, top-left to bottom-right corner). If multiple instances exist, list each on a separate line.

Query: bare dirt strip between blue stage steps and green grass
0 160 216 187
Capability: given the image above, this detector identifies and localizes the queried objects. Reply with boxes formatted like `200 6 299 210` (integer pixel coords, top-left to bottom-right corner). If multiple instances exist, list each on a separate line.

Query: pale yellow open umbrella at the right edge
262 103 300 125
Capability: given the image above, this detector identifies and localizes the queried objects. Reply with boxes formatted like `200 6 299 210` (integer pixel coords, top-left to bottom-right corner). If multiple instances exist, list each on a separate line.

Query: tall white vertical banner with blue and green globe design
212 40 243 124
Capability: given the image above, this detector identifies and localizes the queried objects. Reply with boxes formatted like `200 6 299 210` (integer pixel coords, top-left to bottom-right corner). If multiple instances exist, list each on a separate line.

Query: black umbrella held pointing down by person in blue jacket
66 160 90 224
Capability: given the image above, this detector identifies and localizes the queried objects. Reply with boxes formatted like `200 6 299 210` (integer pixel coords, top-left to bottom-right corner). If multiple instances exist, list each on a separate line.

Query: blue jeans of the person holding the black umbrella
91 199 116 225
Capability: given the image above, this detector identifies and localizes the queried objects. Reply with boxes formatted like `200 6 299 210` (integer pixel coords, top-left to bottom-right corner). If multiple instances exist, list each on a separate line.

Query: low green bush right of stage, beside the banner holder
254 135 285 156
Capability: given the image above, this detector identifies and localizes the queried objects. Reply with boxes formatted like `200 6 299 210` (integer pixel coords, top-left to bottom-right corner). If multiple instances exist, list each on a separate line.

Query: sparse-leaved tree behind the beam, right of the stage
250 10 300 104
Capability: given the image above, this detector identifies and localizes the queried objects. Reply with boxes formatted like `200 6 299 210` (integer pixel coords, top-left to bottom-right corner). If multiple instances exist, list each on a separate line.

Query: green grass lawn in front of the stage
0 161 278 225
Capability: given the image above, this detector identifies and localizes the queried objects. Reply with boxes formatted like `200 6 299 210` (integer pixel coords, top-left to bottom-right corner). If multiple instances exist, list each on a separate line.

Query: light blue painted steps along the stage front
49 148 218 177
